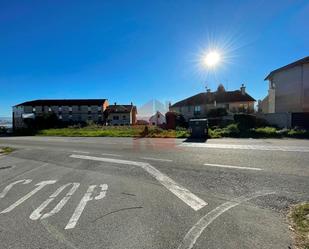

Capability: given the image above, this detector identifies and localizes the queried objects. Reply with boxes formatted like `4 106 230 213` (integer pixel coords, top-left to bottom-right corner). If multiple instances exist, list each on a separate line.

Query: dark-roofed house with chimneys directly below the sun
170 85 255 120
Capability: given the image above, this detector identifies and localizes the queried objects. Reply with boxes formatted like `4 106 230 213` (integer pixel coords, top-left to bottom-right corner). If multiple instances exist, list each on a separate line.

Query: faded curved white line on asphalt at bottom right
178 192 275 249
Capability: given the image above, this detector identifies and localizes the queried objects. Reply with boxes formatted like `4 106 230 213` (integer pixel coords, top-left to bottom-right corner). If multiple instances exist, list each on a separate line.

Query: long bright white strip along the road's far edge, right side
178 143 309 152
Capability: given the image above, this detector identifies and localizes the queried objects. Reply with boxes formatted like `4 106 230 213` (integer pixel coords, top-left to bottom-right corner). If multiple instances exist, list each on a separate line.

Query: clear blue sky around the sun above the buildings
0 0 309 116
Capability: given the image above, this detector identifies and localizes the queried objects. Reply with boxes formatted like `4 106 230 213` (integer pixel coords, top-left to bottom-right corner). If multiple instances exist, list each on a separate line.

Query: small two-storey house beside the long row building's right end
106 103 137 125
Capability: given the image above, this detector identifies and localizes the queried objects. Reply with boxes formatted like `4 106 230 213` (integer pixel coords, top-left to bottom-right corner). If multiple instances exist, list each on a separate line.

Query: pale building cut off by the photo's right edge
259 56 309 113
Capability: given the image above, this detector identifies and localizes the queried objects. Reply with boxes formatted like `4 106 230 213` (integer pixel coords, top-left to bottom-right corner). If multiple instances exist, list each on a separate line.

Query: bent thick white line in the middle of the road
70 155 207 211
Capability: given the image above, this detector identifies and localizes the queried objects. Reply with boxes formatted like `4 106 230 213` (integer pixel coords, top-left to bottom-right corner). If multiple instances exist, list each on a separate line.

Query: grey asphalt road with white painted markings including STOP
0 137 309 249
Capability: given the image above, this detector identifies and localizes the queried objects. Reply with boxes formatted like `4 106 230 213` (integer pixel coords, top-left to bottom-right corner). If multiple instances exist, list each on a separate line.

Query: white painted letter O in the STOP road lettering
30 183 80 220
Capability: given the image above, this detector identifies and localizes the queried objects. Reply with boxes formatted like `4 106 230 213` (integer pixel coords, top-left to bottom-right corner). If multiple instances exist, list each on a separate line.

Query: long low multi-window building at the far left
13 99 108 129
